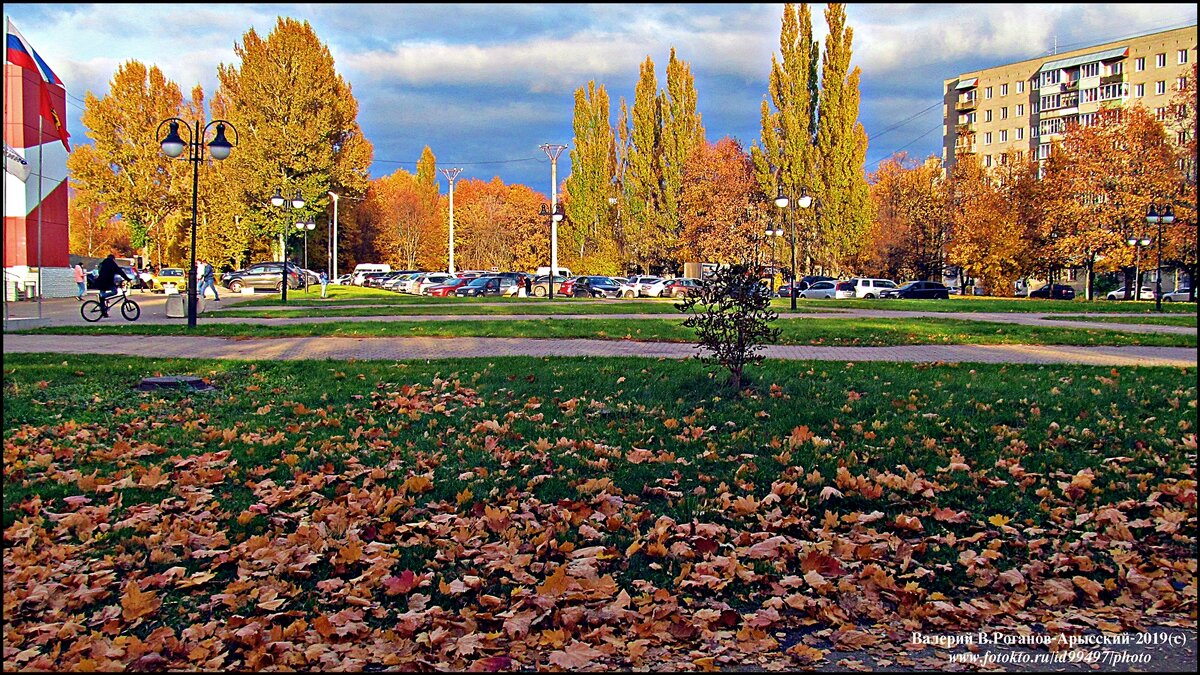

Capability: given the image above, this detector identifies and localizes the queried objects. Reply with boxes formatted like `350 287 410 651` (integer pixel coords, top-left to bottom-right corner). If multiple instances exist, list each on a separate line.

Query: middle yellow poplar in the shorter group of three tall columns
622 56 670 271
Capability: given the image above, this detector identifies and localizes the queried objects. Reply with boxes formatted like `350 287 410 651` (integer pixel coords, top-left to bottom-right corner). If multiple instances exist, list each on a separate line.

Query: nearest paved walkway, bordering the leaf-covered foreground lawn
4 334 1196 368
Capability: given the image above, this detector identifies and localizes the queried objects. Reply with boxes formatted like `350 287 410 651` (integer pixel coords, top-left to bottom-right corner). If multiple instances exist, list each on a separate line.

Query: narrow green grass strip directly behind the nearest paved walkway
24 317 1196 347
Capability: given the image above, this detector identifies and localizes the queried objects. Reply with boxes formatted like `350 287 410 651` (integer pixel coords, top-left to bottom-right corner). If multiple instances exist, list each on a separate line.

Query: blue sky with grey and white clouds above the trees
5 2 1196 193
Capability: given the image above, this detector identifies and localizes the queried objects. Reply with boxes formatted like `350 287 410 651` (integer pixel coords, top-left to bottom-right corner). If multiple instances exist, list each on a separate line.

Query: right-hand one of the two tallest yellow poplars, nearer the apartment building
812 2 871 271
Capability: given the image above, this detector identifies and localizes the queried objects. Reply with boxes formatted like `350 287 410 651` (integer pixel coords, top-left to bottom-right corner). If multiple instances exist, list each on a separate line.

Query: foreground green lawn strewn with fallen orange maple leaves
4 354 1196 670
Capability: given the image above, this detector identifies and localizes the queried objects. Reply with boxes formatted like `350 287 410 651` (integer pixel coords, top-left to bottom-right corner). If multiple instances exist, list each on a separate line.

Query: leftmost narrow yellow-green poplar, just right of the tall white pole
564 80 618 267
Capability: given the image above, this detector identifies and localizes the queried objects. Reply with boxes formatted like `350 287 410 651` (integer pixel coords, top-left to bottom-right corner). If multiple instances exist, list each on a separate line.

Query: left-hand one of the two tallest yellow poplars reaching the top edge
750 4 820 276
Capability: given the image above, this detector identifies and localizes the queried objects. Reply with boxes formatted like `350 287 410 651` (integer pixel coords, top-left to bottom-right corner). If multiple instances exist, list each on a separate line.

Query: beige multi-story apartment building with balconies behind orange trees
942 25 1196 169
